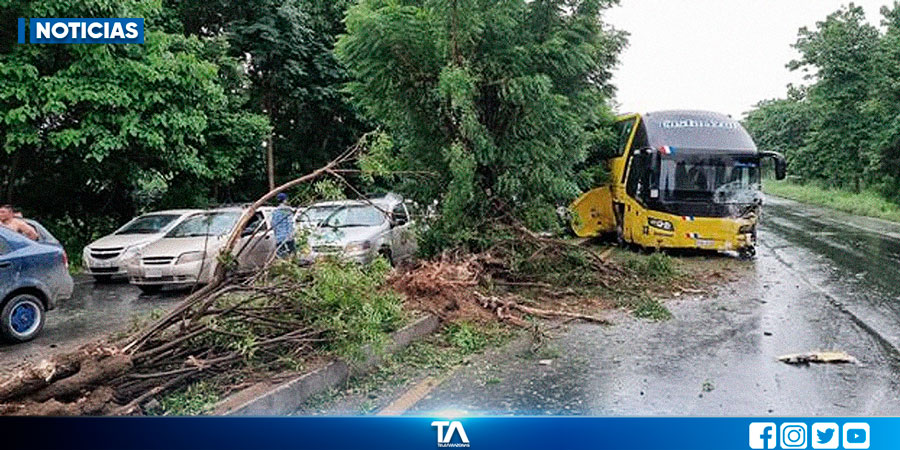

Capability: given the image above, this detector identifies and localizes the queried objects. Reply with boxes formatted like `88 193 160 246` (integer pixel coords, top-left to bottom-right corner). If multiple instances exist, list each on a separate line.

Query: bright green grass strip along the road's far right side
763 180 900 222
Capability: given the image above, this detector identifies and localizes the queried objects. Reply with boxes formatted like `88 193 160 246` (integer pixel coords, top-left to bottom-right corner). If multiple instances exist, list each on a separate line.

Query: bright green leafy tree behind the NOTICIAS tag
0 0 269 250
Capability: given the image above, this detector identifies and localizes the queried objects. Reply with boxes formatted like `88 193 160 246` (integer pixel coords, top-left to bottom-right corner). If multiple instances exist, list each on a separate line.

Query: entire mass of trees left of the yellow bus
0 0 625 253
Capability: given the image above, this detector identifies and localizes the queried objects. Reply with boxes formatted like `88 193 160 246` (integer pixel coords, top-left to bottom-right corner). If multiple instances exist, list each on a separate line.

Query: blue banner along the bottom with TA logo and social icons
0 416 900 450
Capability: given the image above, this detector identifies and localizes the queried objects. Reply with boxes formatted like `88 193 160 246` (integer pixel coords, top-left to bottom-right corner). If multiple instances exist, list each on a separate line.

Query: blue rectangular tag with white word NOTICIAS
18 18 144 44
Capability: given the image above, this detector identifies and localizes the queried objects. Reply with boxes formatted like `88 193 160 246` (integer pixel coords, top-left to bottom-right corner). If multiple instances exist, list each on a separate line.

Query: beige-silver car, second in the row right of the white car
127 207 275 293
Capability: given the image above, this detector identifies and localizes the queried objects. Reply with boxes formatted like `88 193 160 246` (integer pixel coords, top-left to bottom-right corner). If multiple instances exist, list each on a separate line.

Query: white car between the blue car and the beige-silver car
81 209 200 282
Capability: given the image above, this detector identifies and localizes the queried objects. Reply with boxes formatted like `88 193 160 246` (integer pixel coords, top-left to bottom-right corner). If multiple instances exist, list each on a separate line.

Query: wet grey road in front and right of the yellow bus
396 198 900 416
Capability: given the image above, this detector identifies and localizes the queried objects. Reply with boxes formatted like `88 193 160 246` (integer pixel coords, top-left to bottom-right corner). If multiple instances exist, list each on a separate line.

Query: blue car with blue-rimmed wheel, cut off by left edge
0 220 74 342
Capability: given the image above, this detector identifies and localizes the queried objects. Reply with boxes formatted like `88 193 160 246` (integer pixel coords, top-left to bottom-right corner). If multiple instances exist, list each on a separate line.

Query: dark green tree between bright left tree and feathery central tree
167 0 368 186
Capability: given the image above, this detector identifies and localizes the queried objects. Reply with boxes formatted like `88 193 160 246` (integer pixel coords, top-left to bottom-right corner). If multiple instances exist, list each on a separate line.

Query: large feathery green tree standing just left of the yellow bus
336 0 625 250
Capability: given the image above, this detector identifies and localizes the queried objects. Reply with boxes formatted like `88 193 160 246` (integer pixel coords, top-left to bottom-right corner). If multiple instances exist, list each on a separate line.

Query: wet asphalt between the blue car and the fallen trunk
0 276 185 372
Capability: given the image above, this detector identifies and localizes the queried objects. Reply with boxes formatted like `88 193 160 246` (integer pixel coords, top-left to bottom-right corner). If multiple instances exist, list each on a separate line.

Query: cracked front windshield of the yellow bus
651 153 760 204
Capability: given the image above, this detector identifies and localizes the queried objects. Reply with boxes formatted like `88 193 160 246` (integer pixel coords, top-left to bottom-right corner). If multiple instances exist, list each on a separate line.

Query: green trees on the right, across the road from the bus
744 2 900 201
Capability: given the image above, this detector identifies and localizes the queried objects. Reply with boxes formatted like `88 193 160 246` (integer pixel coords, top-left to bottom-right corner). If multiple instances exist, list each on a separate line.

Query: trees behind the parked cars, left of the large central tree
0 0 370 253
